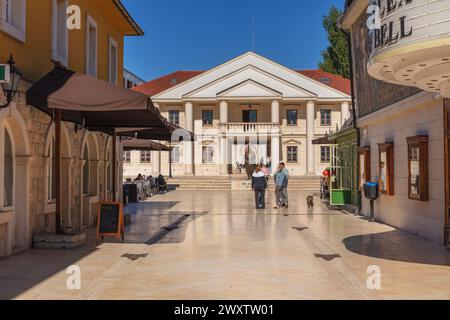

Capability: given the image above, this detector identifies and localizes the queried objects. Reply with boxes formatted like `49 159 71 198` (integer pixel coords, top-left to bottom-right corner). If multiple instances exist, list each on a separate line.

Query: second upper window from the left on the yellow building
52 0 69 66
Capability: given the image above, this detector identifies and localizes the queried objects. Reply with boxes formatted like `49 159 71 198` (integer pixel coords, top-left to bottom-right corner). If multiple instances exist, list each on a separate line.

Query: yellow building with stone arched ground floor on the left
0 0 143 257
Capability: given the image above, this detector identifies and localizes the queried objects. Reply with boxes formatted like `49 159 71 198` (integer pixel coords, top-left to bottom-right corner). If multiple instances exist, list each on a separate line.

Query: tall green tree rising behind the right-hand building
319 6 350 78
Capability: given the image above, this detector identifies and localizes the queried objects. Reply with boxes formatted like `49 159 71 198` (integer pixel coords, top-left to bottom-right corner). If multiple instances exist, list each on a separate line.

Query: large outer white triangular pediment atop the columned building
152 52 350 100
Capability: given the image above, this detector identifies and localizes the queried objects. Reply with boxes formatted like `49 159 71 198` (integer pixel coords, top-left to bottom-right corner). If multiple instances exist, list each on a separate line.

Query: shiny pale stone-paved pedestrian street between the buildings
0 191 450 299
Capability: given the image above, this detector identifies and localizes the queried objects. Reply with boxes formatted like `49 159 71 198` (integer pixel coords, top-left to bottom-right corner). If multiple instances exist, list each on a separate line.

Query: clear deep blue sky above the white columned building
123 0 344 80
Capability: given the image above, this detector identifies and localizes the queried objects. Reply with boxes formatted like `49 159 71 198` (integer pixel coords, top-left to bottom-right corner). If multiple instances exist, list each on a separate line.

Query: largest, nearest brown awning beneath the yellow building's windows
27 66 171 130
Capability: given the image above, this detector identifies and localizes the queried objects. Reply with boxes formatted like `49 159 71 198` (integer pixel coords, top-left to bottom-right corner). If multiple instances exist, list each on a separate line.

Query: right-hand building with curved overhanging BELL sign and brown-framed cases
341 0 450 245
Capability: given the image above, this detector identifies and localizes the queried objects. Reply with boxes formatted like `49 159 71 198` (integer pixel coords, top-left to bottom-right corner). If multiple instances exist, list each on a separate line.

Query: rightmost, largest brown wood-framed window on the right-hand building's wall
407 136 428 201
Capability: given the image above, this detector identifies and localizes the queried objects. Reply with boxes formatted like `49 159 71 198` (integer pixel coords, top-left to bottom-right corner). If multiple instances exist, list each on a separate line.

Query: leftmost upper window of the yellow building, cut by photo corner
0 0 26 42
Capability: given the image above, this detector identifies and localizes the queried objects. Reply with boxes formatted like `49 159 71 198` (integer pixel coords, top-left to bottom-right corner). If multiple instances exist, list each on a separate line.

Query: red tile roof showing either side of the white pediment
133 70 351 96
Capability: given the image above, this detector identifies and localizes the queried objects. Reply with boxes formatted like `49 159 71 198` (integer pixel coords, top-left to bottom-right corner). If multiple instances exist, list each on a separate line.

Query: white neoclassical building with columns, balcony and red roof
124 52 351 178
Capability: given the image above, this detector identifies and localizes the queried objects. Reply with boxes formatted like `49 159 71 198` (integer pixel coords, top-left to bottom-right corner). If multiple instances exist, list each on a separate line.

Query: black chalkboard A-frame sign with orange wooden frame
97 202 124 240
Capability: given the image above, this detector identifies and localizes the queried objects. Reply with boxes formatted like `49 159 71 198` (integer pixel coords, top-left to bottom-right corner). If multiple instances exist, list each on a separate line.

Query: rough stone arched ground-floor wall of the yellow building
0 84 122 257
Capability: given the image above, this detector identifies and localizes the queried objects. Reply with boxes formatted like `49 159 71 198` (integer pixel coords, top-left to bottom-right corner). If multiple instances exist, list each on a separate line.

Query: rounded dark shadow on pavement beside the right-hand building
342 230 450 266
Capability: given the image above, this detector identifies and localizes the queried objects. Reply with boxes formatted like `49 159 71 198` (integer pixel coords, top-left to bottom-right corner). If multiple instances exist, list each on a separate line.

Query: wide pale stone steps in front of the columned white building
168 175 320 192
